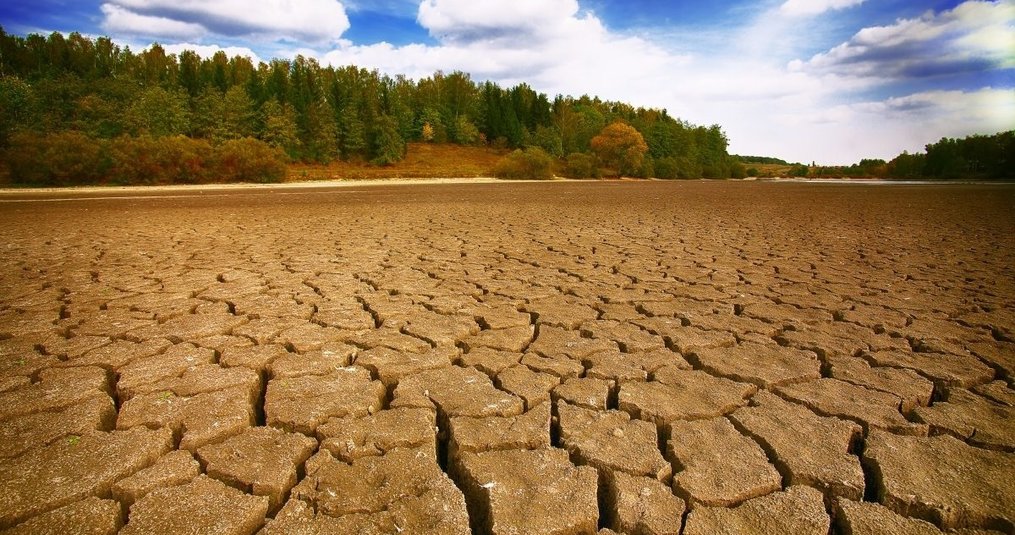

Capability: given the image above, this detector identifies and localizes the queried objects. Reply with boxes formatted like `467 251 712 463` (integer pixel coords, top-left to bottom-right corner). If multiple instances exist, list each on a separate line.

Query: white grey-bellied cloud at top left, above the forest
102 0 349 44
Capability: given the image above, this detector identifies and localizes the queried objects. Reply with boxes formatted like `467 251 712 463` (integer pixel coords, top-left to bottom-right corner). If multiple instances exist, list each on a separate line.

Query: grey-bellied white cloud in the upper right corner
790 1 1015 78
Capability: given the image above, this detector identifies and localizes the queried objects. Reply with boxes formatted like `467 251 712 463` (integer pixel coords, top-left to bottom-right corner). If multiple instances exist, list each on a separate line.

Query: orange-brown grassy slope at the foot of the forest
288 143 509 181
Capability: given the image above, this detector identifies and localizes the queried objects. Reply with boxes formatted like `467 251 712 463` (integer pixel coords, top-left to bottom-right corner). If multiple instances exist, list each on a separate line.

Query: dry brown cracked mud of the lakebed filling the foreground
0 182 1015 534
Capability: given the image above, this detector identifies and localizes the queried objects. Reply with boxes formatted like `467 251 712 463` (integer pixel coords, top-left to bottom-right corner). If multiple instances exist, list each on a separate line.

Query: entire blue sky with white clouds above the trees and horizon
0 0 1015 164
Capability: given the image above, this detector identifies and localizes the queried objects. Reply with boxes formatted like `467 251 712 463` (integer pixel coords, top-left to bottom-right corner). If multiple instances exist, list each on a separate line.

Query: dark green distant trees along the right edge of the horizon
803 130 1015 180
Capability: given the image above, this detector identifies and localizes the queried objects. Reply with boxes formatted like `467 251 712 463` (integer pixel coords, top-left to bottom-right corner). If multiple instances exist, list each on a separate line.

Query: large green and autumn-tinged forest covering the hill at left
0 27 744 185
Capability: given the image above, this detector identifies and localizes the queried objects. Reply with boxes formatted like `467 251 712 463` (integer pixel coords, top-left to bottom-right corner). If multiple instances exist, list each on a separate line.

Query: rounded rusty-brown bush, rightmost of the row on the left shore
213 137 286 183
